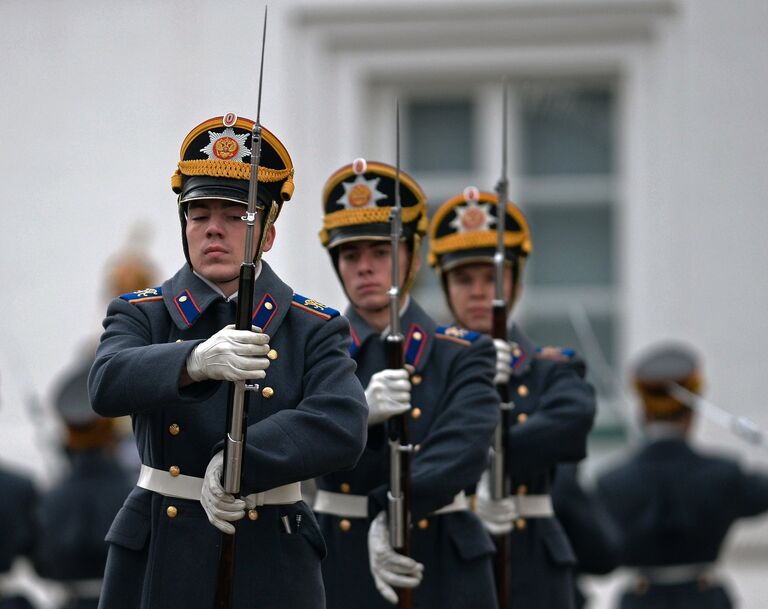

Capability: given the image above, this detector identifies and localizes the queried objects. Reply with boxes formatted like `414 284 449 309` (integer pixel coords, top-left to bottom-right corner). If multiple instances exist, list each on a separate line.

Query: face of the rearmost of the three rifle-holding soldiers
446 263 512 334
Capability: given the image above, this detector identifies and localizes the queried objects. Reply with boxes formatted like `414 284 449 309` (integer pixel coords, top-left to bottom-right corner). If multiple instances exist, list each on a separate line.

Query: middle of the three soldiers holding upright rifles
315 159 498 609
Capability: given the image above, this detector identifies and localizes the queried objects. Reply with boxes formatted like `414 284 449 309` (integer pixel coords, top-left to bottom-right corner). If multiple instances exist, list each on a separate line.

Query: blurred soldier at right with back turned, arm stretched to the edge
598 342 768 609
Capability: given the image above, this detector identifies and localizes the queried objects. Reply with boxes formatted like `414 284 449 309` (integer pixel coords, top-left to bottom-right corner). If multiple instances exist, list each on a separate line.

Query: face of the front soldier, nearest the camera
186 199 275 295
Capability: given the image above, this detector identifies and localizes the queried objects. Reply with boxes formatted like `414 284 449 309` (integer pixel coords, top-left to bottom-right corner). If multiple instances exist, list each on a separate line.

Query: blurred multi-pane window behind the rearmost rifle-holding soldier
408 79 621 433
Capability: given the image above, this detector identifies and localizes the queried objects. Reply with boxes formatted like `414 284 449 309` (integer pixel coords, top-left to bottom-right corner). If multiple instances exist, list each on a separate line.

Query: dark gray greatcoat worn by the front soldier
89 262 367 609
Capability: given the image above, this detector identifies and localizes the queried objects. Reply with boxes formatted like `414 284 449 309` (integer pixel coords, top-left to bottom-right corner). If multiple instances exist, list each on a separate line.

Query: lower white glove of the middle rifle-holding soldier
368 512 424 605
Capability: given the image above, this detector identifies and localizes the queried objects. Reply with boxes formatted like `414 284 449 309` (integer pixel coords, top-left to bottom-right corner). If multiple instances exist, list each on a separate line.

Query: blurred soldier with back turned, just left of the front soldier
34 359 133 609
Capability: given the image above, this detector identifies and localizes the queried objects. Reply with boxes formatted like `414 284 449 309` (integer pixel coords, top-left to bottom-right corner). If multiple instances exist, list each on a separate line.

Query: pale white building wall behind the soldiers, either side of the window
0 0 768 604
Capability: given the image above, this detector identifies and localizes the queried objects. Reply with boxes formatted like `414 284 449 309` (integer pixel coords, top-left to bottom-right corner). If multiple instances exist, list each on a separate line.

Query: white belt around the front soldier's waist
136 464 301 505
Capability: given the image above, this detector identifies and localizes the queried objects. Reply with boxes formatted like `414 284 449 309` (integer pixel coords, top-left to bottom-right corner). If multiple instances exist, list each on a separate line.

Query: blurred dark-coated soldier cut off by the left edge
0 376 38 609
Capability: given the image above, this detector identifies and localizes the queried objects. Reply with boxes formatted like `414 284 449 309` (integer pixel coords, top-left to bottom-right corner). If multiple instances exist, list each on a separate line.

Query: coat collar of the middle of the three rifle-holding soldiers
344 298 437 370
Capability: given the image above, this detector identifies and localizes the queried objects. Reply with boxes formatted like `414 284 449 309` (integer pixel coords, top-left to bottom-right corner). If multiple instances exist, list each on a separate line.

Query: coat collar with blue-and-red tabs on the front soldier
163 260 293 332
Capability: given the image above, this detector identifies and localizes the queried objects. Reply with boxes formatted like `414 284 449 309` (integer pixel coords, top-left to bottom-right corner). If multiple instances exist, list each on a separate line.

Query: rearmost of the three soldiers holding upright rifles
429 188 595 609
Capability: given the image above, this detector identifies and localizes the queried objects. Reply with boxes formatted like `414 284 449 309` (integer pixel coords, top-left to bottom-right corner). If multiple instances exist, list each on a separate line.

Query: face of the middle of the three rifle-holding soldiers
339 241 410 311
